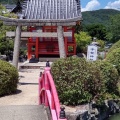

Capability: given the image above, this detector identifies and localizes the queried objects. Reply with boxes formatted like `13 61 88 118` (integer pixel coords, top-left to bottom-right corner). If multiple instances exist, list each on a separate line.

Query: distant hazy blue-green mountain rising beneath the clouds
82 9 120 26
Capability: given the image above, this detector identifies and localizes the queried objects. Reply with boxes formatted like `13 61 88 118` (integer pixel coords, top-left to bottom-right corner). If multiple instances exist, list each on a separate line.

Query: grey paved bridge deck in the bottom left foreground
0 105 49 120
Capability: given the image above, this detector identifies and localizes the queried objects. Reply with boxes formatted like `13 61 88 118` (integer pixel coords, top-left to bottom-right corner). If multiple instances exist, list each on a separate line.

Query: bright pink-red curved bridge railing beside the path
39 67 67 120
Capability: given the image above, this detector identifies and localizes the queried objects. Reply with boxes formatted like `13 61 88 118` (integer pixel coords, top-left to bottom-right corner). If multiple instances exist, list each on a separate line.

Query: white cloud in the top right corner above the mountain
105 0 120 9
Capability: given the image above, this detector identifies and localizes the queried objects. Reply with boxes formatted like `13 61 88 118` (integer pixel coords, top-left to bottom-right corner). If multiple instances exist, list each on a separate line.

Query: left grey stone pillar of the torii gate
13 25 21 68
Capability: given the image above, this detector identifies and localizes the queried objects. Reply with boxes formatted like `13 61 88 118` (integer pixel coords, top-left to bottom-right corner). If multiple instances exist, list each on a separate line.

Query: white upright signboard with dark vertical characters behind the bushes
87 45 97 61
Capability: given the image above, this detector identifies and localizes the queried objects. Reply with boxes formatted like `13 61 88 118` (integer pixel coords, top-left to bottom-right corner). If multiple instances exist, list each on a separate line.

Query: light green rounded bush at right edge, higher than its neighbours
106 48 120 75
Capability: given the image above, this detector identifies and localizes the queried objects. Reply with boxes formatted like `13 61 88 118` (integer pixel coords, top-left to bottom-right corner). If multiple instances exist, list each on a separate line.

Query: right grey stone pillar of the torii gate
57 26 66 58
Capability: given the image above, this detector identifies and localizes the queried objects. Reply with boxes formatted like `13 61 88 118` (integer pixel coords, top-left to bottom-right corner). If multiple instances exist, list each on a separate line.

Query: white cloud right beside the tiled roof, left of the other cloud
81 0 100 12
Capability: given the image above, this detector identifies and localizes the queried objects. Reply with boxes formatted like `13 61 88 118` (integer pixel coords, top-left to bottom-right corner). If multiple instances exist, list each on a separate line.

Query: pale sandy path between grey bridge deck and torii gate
0 70 40 106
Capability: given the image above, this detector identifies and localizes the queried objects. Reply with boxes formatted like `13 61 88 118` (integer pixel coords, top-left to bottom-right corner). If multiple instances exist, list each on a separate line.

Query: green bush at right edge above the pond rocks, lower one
94 61 120 99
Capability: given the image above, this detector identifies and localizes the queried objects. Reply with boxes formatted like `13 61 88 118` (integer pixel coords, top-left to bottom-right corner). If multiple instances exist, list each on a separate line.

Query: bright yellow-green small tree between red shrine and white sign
75 32 92 53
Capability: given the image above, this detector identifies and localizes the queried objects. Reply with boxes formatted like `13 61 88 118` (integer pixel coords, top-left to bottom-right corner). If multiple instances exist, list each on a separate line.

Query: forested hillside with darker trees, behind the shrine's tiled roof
0 0 120 42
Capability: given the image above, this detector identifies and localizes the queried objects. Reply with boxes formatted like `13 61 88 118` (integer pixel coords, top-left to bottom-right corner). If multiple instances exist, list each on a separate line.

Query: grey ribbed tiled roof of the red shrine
22 0 81 20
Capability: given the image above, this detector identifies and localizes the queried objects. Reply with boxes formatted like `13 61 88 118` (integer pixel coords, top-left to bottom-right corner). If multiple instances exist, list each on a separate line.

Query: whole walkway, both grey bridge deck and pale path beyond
0 69 48 120
